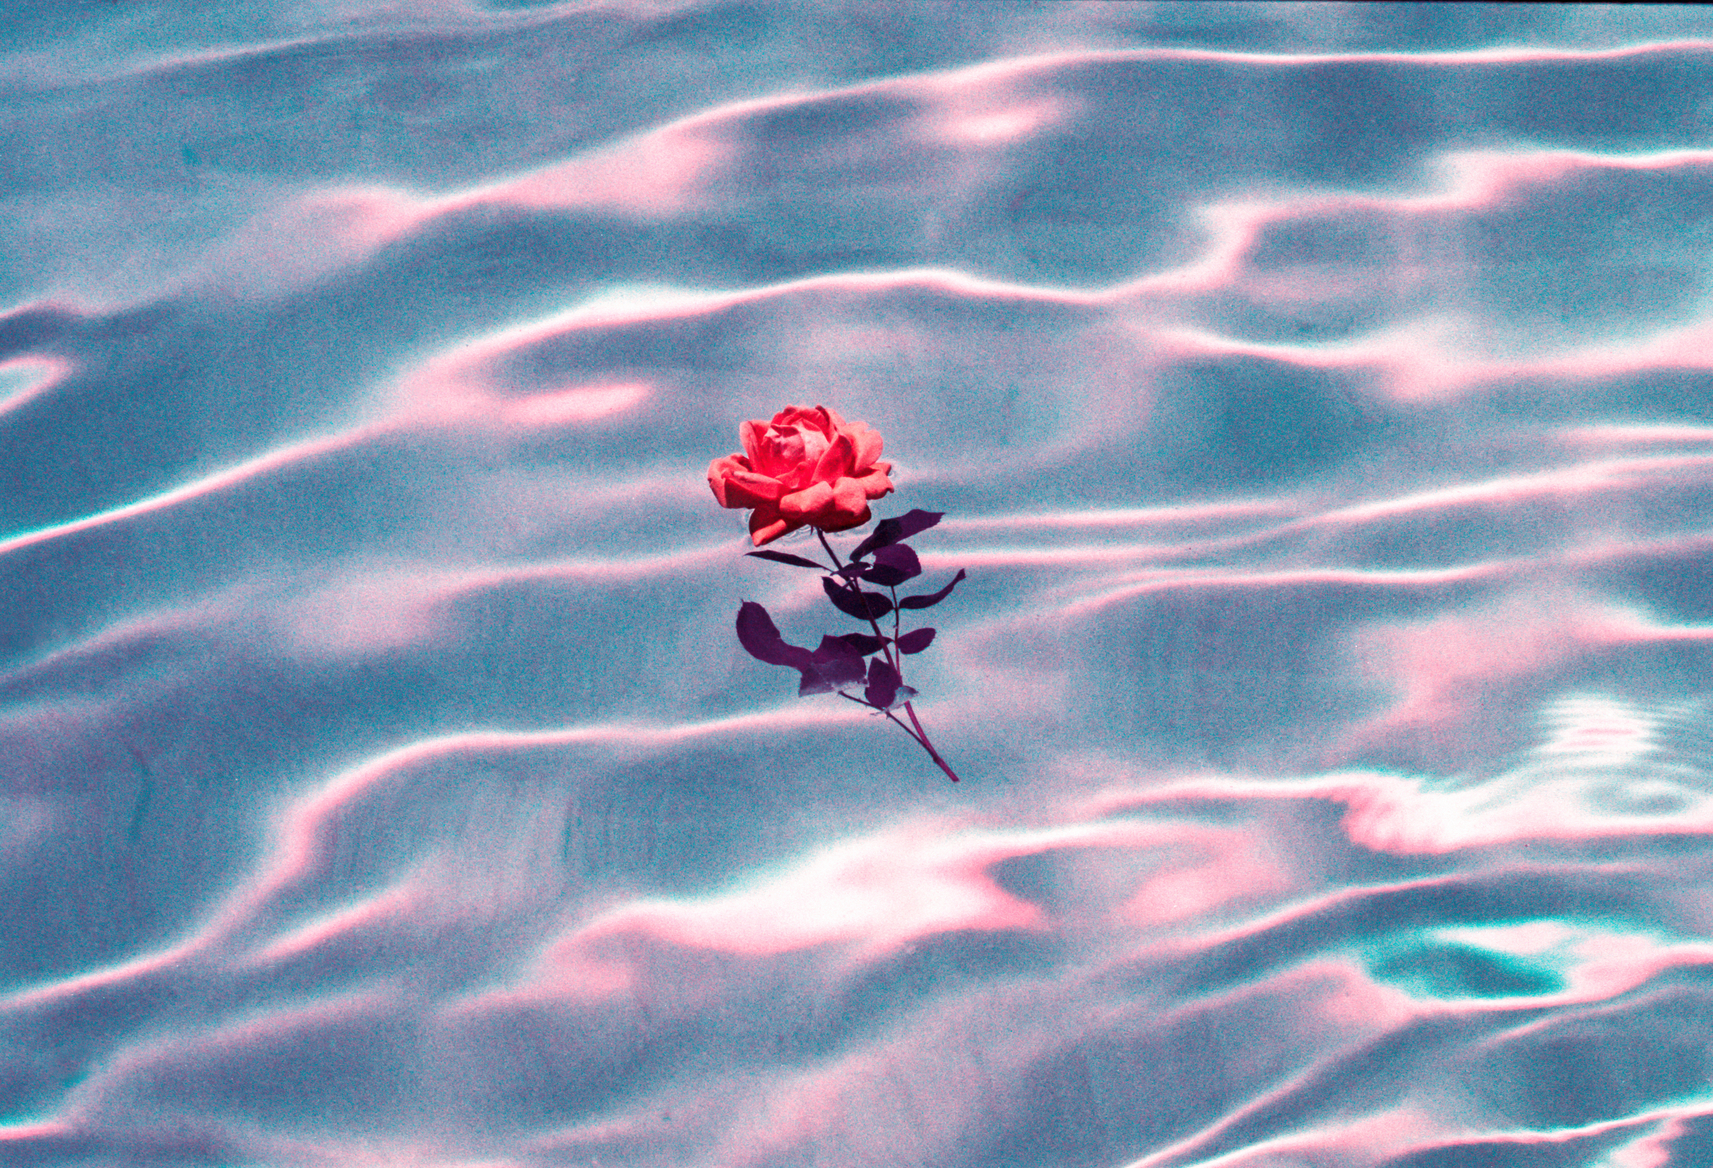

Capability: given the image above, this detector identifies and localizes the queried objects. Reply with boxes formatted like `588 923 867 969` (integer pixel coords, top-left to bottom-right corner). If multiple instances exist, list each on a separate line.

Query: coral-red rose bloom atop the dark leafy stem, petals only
707 406 892 548
